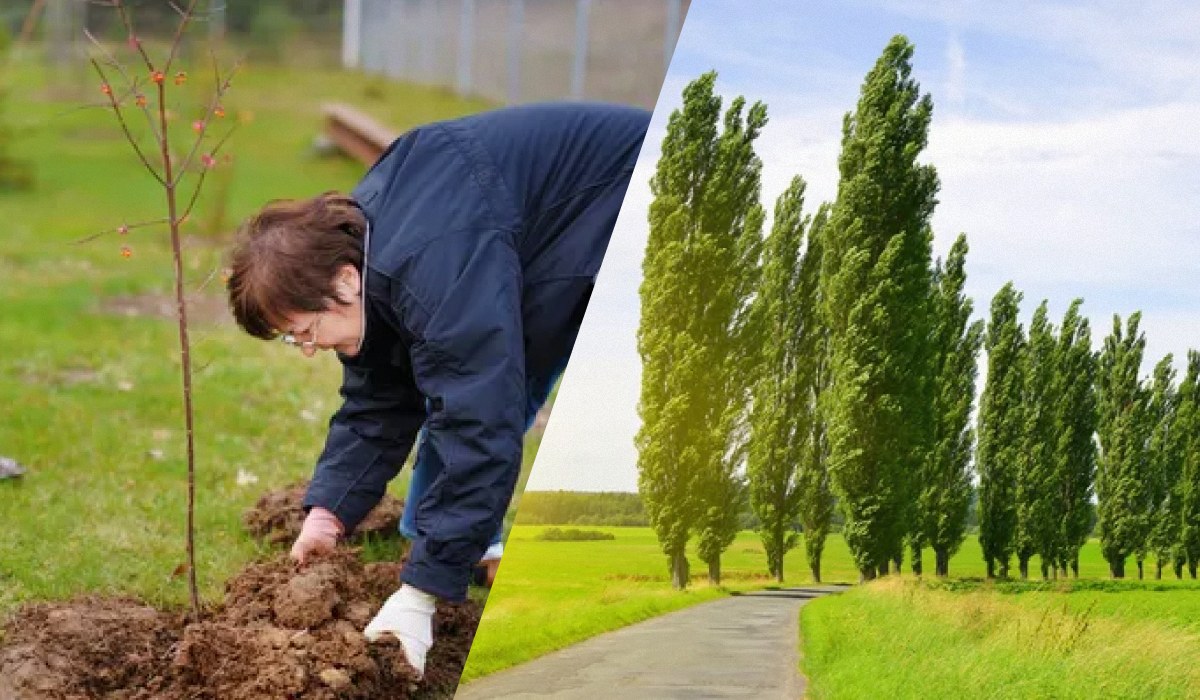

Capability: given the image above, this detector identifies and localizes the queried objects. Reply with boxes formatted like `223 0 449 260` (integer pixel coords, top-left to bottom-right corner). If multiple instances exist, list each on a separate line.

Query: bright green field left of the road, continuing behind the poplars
463 525 1200 696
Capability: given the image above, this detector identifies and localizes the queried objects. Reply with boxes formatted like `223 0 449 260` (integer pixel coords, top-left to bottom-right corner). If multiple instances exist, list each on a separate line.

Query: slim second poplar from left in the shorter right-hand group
1015 301 1058 579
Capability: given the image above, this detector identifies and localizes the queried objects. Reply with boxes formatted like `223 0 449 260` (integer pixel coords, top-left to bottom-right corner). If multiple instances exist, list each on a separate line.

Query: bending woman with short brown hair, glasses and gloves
228 103 650 672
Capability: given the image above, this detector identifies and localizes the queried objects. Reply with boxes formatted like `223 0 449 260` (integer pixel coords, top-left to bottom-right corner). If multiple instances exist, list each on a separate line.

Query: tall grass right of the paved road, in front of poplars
800 578 1200 700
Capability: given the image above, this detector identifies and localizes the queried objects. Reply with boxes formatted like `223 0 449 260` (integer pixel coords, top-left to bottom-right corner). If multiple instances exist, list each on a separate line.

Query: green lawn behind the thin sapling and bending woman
0 51 533 617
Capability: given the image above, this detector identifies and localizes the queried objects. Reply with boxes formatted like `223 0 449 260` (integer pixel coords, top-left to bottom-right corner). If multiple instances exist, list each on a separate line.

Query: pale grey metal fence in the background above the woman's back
342 0 691 108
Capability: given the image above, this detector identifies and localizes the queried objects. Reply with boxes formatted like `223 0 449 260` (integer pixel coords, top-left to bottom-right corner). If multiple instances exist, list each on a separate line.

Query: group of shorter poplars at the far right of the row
978 290 1200 579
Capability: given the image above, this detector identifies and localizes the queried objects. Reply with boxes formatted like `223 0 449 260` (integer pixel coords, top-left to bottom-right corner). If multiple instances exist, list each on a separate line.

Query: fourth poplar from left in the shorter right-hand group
1096 313 1151 579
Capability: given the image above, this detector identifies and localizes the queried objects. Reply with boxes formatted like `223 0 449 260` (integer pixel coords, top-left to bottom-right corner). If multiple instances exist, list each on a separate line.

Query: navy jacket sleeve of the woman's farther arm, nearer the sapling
304 358 425 534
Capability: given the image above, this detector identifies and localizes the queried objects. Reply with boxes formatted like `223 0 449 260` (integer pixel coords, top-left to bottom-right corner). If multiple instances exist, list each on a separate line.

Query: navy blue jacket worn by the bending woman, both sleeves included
305 103 650 600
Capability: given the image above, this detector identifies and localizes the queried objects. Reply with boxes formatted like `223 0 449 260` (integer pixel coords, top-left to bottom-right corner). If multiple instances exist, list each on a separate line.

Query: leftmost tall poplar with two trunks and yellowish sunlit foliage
636 72 767 587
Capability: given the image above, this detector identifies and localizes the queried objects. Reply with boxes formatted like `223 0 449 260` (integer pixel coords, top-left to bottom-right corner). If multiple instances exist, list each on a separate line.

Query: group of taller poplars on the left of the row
636 36 964 586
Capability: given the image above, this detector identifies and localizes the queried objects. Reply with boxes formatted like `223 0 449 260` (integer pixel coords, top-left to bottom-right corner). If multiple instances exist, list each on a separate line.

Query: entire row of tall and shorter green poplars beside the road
636 36 1200 587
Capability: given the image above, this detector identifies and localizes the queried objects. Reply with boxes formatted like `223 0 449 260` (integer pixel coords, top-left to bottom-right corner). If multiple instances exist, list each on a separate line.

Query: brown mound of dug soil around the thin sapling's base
0 551 482 700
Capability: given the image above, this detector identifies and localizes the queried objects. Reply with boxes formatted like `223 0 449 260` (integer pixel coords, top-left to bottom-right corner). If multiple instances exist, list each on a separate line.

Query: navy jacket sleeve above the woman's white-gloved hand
395 232 526 600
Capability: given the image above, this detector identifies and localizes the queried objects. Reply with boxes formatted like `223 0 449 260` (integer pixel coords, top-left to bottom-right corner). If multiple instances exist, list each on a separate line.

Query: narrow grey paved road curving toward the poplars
455 586 845 700
